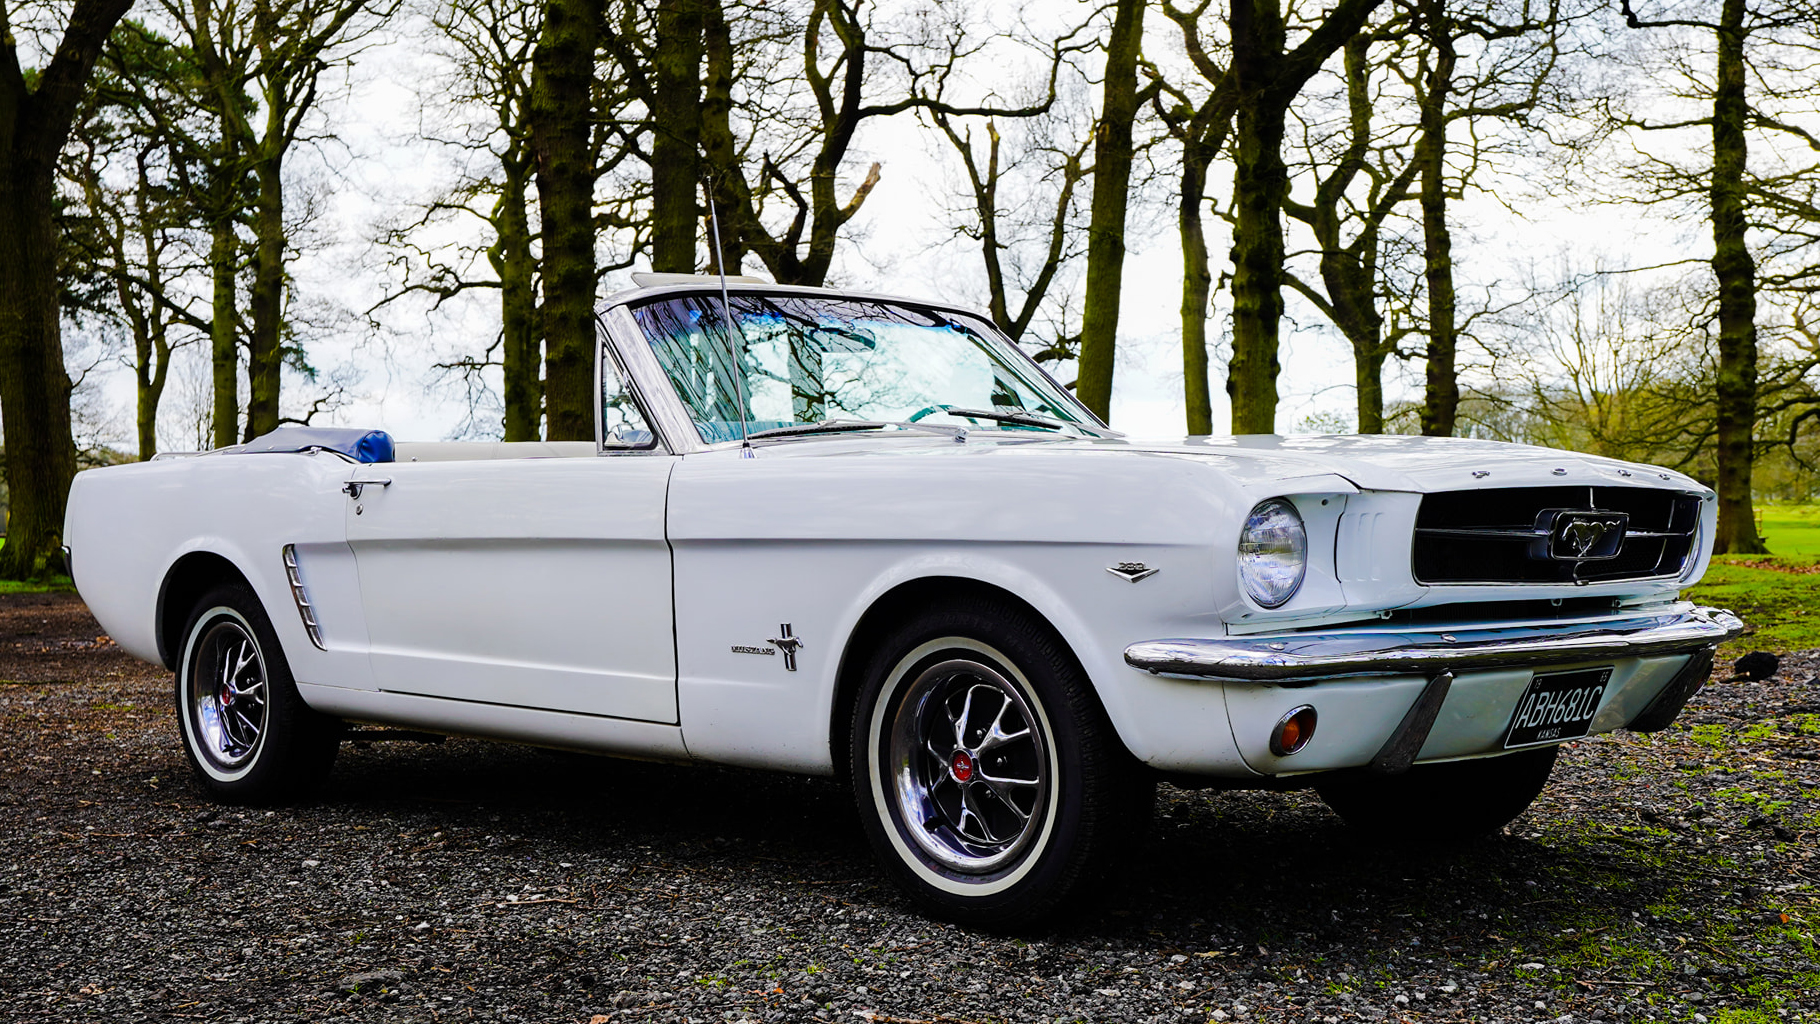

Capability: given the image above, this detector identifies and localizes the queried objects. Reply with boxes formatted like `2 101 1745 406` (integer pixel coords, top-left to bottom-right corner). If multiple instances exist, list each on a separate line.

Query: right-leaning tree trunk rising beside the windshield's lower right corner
1074 0 1145 422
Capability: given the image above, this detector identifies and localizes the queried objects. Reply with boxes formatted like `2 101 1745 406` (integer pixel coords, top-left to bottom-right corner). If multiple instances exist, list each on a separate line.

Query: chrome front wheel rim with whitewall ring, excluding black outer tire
886 657 1054 875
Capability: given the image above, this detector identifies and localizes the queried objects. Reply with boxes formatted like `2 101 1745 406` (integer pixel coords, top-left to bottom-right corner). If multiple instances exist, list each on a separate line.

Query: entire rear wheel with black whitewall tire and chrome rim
177 586 340 804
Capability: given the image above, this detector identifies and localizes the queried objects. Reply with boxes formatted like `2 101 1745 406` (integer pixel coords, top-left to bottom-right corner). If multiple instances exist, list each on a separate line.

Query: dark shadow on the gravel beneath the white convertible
313 740 1711 946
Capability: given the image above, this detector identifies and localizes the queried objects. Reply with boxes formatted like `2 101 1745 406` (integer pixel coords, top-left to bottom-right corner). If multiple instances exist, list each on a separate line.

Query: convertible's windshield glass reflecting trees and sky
632 293 1097 442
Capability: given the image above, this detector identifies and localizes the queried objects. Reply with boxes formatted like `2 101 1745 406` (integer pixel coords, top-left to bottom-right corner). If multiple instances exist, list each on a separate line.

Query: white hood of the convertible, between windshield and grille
759 431 1707 493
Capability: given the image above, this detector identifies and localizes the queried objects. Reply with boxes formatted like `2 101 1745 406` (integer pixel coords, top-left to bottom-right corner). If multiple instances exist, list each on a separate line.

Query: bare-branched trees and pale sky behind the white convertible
0 0 1820 578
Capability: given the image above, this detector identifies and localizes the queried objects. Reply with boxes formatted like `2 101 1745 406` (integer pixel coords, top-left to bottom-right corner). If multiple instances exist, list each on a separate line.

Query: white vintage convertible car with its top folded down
66 275 1742 924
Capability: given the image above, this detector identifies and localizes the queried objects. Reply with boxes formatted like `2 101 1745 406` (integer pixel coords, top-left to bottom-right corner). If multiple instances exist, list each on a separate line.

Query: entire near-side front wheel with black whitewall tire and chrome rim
850 600 1154 928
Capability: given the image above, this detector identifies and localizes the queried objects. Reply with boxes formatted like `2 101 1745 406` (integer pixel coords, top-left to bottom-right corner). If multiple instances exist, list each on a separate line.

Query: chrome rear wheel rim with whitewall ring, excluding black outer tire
184 615 271 771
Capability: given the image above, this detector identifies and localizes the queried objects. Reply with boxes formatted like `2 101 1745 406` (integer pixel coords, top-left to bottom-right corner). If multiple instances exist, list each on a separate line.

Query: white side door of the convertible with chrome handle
348 367 677 724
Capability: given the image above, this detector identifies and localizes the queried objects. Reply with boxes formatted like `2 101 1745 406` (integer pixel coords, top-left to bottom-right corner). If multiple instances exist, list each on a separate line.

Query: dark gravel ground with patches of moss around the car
0 595 1820 1024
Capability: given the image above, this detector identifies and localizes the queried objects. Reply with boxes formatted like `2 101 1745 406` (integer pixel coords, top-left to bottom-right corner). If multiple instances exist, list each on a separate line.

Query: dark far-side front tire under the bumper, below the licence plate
1314 746 1560 842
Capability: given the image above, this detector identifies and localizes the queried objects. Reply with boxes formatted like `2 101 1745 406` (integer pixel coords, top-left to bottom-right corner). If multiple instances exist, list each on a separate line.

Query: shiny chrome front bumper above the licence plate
1125 606 1744 686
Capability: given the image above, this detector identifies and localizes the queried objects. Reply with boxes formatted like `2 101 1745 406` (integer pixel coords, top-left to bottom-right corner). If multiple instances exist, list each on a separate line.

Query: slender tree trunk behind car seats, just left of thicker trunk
488 166 544 440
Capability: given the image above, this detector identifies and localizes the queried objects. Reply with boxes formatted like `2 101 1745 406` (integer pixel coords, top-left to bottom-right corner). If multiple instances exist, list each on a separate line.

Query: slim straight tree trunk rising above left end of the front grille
1416 0 1460 437
